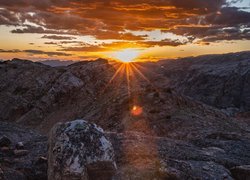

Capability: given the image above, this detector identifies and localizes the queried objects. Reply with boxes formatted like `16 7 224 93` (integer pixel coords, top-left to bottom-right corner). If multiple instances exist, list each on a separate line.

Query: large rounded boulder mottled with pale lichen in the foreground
48 120 116 180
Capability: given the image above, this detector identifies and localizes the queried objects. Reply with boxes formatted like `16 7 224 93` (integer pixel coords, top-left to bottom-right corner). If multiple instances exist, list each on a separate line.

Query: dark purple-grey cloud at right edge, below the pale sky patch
170 7 250 43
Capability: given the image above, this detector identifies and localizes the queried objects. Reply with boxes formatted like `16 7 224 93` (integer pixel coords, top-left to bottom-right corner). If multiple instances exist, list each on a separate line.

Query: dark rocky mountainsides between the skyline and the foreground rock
0 52 250 135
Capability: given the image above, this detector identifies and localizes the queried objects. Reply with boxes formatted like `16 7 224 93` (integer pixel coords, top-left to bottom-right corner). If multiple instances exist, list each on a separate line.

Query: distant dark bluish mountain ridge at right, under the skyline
157 52 250 115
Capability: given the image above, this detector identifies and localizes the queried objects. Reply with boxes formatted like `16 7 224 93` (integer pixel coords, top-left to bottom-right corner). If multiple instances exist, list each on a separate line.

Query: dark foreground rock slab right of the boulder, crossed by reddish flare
109 132 250 179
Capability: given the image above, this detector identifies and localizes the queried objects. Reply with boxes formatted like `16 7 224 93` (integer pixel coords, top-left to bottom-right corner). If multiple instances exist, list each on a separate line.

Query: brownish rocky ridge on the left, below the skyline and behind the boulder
0 59 114 132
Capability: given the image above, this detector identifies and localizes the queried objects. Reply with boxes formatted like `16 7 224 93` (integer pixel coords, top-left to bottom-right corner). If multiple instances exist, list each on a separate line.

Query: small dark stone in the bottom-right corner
231 165 250 180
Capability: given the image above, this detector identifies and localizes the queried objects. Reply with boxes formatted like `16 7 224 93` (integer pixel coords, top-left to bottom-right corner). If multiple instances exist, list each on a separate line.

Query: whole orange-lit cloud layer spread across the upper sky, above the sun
0 0 250 51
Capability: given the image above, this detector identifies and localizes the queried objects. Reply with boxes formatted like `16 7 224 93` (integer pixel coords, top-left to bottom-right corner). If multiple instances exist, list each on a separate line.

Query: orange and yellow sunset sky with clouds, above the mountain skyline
0 0 250 61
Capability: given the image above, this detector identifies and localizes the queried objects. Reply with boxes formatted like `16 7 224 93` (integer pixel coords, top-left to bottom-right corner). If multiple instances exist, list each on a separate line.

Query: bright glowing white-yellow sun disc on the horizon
112 49 140 63
